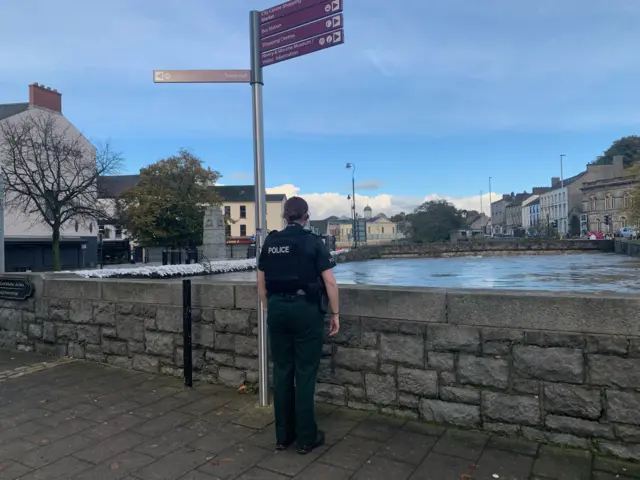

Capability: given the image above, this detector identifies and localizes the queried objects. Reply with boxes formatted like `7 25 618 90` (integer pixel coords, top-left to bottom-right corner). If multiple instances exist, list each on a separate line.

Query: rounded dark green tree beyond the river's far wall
407 200 465 243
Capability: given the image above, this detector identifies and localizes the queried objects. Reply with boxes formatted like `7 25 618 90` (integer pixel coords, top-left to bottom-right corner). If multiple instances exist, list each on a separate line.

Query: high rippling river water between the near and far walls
218 253 640 293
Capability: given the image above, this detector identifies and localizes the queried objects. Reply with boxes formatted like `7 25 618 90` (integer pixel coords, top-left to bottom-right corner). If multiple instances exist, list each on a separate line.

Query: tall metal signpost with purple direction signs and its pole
153 0 344 406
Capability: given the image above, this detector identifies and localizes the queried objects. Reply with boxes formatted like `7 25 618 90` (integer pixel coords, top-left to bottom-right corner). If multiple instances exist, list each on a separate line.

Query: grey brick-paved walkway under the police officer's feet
0 351 640 480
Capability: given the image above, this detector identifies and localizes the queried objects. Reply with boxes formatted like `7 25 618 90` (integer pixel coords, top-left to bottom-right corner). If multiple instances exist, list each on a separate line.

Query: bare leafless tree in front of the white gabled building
0 114 122 270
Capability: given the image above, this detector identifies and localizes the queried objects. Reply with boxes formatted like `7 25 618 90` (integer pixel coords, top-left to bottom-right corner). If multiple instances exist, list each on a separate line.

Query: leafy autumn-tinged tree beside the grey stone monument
118 150 221 247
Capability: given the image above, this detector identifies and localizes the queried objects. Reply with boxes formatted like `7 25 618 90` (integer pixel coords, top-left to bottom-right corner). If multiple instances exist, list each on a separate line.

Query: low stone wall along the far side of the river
337 238 614 262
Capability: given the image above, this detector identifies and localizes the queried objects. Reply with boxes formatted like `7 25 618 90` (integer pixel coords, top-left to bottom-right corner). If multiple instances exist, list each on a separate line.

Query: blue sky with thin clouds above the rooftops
0 0 640 218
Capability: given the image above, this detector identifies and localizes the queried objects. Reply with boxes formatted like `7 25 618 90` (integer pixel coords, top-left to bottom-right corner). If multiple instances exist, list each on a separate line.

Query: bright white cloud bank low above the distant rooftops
267 184 499 220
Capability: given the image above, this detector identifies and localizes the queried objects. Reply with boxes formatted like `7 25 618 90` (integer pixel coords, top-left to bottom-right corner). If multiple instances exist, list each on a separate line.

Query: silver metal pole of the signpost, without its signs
249 10 269 407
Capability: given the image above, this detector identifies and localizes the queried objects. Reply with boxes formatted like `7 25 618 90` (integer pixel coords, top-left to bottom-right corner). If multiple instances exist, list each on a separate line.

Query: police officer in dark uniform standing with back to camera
258 197 340 454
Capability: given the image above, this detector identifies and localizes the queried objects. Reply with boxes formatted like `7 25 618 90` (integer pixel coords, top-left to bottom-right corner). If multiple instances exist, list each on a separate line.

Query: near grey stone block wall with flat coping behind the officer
0 277 640 459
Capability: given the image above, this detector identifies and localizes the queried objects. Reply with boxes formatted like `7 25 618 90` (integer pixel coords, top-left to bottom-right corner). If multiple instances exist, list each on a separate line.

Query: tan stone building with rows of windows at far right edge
581 163 640 235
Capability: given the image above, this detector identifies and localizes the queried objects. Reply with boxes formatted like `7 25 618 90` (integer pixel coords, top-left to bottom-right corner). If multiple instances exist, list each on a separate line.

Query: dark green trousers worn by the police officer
267 295 324 445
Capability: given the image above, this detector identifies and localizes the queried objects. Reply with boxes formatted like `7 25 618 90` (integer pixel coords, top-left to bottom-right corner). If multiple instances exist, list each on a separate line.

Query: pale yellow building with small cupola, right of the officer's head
324 206 404 247
